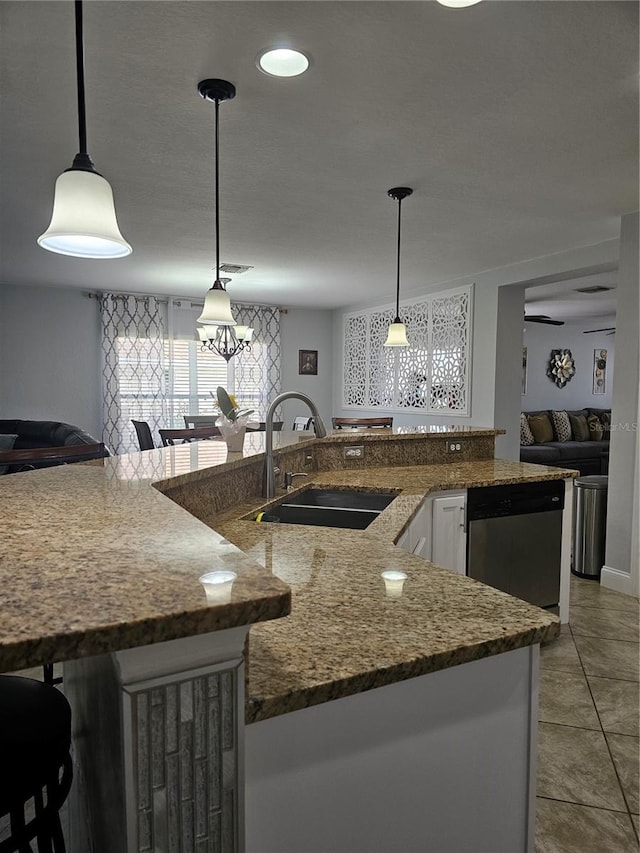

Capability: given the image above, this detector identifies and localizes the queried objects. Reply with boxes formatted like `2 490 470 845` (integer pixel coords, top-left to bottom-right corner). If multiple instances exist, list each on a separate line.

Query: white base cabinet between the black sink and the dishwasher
396 491 467 575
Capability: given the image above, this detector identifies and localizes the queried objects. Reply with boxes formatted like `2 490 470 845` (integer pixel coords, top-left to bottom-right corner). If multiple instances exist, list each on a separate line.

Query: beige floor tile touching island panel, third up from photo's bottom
538 670 600 731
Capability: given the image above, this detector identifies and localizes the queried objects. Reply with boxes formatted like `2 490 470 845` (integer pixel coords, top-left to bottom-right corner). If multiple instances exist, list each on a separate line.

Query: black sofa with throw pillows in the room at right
520 409 611 476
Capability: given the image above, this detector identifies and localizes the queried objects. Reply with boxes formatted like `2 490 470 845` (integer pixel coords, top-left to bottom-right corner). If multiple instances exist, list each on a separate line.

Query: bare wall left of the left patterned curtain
0 284 102 438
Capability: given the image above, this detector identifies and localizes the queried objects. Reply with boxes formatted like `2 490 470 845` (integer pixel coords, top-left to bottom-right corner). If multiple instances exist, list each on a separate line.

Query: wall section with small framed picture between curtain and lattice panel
280 308 333 429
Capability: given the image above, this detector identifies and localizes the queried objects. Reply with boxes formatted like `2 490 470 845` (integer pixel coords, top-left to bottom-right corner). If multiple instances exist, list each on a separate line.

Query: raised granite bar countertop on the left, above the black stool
0 433 313 672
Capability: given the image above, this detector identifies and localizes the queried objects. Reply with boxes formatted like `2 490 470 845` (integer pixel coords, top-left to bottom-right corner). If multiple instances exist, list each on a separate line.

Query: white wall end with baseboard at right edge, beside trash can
601 213 640 595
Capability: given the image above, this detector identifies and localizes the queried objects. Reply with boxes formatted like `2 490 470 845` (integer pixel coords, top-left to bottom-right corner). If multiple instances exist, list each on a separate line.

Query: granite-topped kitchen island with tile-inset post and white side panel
0 430 571 853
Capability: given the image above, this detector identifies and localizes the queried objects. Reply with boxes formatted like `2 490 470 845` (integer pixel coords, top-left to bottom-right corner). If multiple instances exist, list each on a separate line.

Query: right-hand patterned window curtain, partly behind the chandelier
229 303 281 420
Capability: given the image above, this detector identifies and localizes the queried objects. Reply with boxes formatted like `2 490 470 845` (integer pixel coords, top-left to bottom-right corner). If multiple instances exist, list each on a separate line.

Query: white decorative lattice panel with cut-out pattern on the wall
343 286 473 416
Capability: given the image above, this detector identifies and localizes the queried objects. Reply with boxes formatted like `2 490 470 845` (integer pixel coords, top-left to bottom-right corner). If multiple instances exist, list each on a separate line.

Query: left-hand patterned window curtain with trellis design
100 293 167 454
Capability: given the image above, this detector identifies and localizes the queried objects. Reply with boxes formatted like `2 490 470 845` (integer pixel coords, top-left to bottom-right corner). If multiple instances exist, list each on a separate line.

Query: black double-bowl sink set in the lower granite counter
255 488 396 530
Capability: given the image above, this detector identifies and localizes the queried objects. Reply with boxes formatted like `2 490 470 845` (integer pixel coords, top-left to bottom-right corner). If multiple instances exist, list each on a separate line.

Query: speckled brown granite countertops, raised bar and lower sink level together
0 431 571 721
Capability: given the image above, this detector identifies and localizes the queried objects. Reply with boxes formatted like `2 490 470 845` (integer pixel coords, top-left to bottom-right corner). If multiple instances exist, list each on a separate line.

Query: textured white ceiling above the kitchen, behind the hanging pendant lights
0 0 638 313
